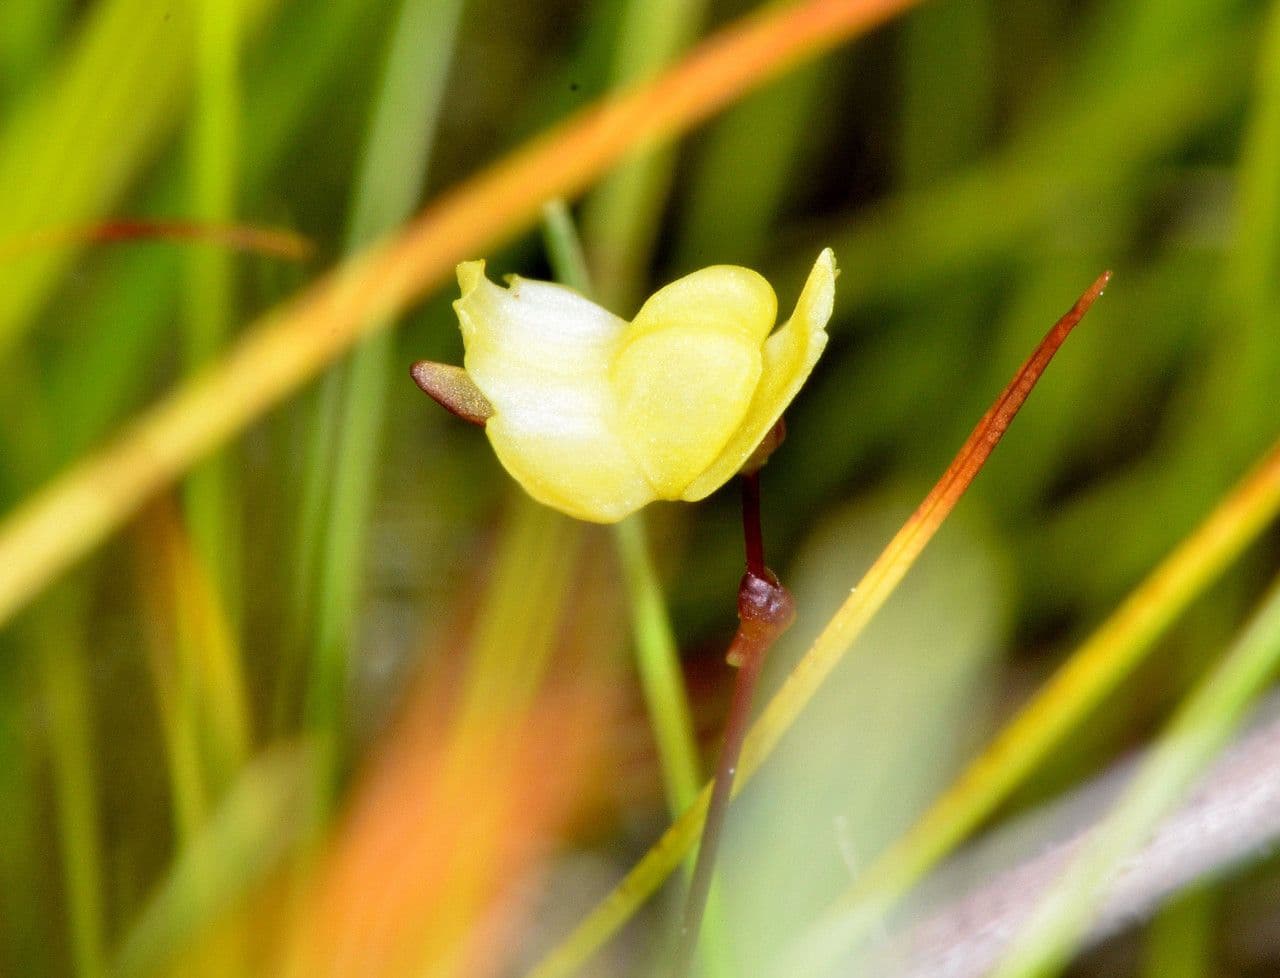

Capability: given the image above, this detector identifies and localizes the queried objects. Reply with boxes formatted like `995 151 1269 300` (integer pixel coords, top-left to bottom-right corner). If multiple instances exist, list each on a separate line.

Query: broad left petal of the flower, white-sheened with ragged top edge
453 261 654 522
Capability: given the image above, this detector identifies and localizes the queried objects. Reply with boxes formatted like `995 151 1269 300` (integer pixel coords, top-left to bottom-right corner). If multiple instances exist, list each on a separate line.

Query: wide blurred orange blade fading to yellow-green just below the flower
275 494 618 978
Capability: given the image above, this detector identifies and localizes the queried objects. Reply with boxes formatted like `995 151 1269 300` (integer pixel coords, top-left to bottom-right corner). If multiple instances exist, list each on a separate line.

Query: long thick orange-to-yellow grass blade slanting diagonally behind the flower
0 0 916 625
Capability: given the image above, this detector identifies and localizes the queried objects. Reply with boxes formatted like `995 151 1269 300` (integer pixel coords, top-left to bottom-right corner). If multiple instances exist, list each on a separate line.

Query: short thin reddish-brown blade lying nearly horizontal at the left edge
0 219 315 261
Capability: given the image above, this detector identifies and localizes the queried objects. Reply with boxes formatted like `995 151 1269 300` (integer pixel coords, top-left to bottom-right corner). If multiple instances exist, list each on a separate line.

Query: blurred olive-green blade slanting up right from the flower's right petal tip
782 24 1252 315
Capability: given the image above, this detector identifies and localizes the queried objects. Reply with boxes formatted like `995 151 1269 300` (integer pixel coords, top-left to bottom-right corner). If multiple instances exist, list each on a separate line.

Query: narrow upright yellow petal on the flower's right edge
681 248 837 502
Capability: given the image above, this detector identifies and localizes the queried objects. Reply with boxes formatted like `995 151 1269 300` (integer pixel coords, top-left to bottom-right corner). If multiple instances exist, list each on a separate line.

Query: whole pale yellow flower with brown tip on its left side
413 248 836 522
